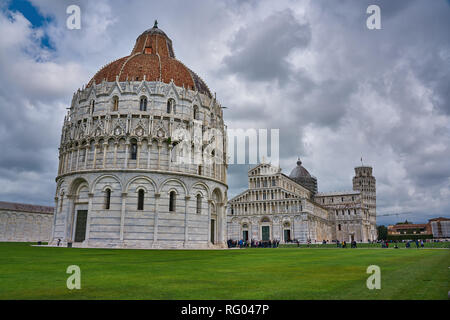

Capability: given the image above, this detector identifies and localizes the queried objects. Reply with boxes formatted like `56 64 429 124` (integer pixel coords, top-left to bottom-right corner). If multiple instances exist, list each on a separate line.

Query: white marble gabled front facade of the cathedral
227 163 332 243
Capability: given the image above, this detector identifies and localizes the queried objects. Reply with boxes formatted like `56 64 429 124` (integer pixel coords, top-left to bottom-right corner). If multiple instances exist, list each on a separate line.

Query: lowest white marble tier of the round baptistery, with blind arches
52 172 226 248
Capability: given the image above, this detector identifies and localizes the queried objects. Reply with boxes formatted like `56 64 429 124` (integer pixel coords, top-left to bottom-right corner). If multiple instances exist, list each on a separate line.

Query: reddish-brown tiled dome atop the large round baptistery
87 21 212 98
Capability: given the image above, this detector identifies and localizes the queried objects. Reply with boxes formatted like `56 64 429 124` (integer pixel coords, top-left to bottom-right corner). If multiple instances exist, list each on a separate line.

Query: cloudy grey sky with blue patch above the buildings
0 0 450 224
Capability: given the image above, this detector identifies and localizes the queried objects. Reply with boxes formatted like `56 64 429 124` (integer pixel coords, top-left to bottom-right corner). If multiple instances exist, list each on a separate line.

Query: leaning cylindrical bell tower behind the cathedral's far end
353 166 377 240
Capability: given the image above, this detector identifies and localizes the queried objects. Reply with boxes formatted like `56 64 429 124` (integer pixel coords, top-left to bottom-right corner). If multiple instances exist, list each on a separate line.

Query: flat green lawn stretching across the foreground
0 243 450 299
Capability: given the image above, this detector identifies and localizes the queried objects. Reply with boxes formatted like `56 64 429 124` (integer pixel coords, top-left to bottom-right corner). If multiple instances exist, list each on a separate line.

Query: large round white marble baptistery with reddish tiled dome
50 22 227 248
